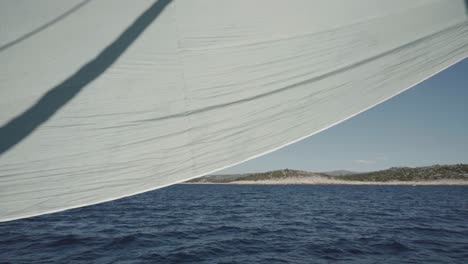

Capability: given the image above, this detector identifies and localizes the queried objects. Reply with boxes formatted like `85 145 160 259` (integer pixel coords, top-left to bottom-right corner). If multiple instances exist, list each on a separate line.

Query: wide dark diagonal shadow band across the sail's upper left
0 0 172 155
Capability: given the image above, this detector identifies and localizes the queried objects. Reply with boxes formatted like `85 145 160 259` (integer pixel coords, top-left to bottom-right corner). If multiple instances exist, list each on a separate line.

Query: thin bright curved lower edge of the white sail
0 56 468 222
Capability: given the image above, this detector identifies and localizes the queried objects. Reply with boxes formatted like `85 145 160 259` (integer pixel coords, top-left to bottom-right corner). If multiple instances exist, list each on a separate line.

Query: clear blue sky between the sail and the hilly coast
217 59 468 174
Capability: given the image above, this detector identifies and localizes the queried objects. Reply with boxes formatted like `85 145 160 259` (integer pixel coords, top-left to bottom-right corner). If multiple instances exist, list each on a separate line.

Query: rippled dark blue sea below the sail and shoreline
0 185 468 264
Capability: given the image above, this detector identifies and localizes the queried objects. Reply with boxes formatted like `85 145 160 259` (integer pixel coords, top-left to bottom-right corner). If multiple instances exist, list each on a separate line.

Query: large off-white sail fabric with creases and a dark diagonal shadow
0 0 468 221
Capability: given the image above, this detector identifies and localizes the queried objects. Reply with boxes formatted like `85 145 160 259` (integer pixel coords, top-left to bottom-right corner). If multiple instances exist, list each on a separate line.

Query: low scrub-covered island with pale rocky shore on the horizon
185 164 468 185
